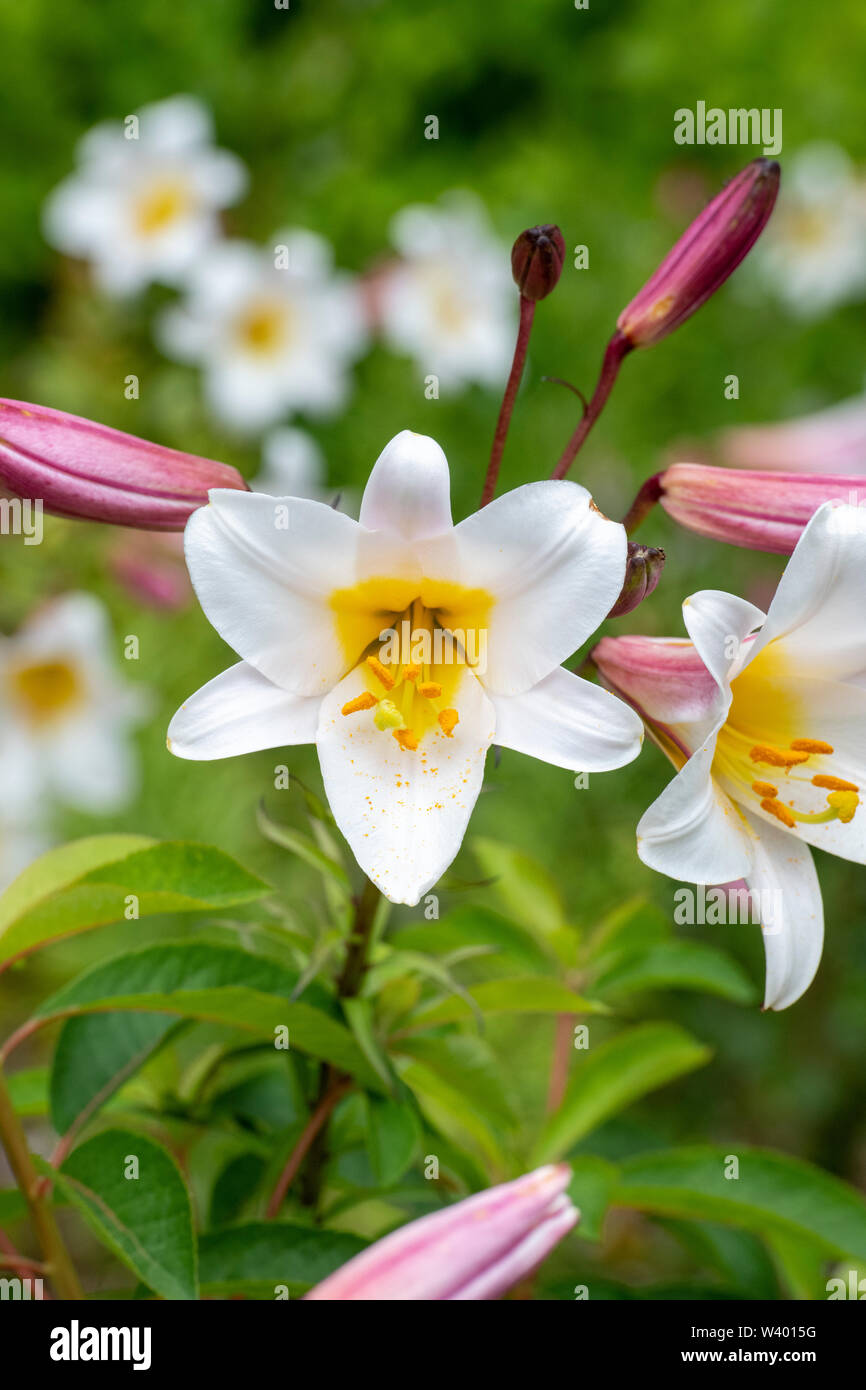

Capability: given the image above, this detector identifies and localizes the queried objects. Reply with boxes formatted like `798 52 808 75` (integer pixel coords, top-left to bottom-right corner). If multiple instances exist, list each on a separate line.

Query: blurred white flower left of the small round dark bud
377 193 517 388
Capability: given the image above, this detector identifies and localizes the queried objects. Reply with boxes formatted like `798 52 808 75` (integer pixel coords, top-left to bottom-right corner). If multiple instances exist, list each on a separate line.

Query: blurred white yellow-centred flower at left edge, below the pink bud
0 594 146 823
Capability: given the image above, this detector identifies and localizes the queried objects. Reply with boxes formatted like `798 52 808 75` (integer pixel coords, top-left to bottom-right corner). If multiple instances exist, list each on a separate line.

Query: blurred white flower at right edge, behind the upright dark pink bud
756 143 866 318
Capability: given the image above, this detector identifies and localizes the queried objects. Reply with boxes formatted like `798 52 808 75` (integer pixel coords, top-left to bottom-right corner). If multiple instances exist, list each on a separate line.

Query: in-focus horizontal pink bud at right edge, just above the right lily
657 463 866 555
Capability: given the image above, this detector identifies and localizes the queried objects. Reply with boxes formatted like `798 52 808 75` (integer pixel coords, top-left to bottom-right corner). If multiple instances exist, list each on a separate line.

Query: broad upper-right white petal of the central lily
420 481 626 695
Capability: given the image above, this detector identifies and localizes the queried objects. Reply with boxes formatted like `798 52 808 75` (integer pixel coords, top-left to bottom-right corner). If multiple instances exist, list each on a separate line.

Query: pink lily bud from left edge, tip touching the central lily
0 399 246 531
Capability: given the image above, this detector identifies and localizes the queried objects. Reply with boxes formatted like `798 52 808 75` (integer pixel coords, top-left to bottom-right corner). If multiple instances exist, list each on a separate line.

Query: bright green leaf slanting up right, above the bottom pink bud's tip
532 1023 710 1166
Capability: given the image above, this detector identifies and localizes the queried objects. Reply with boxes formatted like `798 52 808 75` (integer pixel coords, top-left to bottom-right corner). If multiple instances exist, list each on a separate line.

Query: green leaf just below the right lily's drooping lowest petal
594 941 756 1004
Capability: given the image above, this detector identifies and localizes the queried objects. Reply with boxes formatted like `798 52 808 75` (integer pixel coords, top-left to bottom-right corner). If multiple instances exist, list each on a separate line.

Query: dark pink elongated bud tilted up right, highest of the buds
617 158 780 348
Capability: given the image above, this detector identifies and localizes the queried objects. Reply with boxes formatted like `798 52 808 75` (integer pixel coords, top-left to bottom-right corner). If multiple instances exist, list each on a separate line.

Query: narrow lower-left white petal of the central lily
168 662 321 760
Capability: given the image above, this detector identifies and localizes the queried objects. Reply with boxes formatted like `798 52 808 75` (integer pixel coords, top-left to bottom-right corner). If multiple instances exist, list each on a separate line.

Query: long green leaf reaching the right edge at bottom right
613 1144 866 1259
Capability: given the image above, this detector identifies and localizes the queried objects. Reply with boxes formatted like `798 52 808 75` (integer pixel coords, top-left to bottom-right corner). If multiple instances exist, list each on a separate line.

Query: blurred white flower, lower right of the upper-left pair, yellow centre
157 229 367 431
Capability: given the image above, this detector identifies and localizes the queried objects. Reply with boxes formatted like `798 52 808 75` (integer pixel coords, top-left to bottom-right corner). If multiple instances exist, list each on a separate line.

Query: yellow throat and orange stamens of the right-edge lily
713 644 860 830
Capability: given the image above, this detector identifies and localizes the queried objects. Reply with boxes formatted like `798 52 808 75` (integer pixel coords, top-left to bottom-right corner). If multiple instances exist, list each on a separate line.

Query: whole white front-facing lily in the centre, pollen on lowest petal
168 431 642 904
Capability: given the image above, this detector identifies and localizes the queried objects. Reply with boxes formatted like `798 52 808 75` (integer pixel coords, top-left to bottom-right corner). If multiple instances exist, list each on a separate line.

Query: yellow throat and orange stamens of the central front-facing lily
331 580 493 752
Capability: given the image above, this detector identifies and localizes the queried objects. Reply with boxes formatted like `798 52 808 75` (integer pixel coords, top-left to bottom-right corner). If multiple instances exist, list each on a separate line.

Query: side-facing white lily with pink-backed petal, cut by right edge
592 503 866 1009
